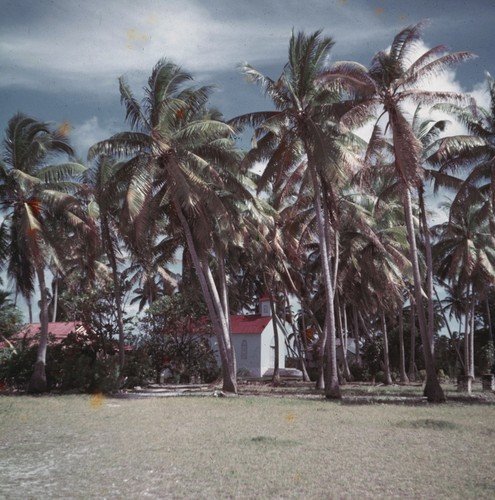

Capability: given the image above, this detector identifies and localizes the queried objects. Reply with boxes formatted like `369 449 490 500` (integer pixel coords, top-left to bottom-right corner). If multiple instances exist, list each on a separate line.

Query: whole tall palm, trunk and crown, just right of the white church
230 31 360 398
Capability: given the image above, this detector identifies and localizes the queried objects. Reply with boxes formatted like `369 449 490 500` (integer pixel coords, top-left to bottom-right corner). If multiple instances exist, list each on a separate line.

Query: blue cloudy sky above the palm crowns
0 0 495 320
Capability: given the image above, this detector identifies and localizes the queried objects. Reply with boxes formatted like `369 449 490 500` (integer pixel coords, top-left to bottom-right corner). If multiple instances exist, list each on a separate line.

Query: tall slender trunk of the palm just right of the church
307 160 342 399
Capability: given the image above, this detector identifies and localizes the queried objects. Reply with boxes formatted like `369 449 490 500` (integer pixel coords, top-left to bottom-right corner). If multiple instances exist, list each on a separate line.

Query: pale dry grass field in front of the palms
0 396 495 499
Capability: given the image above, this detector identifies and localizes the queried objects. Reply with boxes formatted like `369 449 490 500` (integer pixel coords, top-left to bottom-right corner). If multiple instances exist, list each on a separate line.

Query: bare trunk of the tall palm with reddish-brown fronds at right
404 188 445 403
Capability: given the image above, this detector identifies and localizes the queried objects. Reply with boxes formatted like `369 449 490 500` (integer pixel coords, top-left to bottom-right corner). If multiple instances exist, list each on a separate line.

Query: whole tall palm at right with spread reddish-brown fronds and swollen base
322 23 473 402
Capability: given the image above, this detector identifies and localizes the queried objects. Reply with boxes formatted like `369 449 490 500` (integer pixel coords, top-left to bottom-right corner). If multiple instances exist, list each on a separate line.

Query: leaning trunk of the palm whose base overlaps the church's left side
173 198 237 393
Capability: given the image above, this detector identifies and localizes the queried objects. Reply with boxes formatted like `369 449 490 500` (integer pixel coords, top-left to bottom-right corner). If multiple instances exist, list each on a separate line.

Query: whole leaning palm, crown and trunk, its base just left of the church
89 59 249 392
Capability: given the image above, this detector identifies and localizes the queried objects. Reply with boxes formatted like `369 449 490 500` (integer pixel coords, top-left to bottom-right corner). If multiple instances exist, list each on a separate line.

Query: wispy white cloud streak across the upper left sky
0 0 393 93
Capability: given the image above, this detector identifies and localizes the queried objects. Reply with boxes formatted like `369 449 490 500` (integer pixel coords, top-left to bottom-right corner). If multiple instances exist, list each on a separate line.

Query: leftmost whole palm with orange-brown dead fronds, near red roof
0 113 85 392
